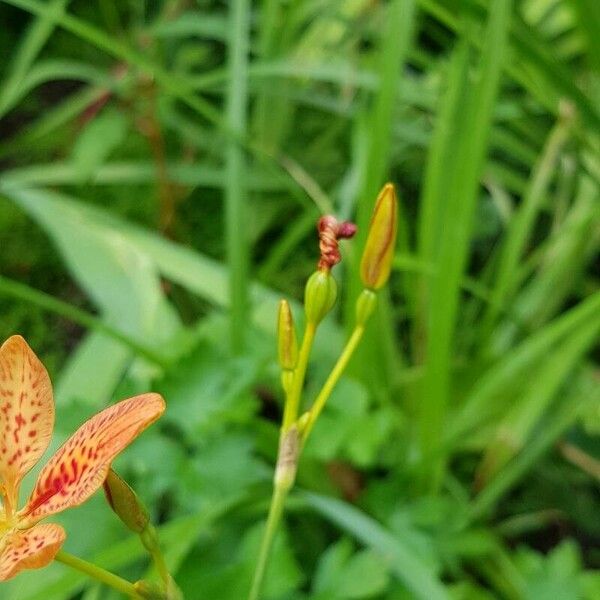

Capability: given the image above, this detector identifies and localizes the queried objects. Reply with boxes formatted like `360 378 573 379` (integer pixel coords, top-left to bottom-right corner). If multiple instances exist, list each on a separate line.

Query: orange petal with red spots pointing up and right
19 394 165 523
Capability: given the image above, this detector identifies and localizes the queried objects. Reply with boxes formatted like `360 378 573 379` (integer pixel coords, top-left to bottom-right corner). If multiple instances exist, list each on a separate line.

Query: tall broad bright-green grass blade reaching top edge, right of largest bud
420 0 512 490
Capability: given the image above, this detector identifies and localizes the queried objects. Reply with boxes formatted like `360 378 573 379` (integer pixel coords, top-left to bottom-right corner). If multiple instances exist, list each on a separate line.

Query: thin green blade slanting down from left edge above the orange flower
0 275 169 369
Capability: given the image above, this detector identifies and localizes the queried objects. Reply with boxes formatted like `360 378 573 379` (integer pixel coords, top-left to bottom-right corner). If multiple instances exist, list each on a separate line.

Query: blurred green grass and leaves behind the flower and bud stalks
0 0 600 600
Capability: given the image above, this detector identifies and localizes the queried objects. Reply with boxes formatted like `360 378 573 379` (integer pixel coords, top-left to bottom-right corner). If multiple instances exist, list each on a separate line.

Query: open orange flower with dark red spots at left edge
0 335 165 581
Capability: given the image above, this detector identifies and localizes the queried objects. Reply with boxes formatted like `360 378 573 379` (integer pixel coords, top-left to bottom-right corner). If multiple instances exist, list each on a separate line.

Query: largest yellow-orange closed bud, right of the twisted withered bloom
360 183 398 290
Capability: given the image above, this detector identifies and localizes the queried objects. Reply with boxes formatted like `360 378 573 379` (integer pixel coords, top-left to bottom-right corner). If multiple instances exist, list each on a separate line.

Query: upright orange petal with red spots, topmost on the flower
0 335 54 508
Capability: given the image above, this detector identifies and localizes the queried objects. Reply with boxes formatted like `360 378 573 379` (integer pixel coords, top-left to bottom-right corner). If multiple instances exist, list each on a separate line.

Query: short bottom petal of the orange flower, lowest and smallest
0 523 66 581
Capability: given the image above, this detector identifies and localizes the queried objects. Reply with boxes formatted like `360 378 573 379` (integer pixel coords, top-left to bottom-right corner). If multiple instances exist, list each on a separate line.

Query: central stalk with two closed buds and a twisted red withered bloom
248 184 397 600
